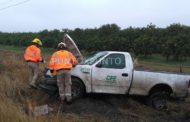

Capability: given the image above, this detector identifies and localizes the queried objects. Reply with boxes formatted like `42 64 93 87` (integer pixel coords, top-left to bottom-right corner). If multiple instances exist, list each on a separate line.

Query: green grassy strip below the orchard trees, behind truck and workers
0 45 190 74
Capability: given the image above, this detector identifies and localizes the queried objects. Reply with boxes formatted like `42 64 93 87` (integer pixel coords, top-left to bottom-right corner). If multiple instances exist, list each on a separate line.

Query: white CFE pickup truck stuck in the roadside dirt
40 51 190 109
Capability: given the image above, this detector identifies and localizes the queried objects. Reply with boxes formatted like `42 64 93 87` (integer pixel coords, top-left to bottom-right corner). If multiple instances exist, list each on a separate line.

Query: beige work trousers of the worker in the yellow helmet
28 62 40 84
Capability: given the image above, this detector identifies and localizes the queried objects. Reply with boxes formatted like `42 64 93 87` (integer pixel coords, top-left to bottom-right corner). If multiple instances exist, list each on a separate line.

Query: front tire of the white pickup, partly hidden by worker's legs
72 78 85 100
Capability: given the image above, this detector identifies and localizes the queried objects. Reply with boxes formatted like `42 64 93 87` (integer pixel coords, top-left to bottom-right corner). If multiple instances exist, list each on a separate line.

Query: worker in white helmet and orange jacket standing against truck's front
49 42 77 103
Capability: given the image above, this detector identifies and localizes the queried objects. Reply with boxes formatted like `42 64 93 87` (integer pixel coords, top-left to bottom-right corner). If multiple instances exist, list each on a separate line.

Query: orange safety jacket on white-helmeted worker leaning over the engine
49 50 77 71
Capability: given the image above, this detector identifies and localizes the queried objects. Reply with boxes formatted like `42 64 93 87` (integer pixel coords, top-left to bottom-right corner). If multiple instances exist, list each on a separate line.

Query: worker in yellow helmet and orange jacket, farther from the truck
24 38 45 88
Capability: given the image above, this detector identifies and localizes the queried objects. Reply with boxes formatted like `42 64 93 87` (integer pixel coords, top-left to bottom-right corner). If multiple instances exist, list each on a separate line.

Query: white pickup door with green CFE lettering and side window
92 53 131 94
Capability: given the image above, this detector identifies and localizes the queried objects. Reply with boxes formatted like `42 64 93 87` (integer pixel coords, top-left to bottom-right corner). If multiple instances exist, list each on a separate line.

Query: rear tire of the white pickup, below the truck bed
146 91 169 110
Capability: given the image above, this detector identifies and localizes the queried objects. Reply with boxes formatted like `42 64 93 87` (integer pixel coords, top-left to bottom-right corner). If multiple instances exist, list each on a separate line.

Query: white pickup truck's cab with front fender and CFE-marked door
72 51 133 94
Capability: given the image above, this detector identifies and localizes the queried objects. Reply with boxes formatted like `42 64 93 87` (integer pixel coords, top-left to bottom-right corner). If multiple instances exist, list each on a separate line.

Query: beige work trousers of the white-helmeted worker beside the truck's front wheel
57 70 72 100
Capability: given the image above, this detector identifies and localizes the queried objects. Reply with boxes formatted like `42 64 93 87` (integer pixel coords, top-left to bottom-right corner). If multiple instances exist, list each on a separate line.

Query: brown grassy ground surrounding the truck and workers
0 47 190 122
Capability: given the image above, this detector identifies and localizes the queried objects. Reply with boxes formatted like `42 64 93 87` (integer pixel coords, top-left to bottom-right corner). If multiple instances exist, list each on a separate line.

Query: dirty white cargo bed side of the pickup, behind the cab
130 70 190 97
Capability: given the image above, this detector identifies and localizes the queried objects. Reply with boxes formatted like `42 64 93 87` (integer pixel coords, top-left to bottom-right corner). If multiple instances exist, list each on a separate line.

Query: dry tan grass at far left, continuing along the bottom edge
0 52 106 122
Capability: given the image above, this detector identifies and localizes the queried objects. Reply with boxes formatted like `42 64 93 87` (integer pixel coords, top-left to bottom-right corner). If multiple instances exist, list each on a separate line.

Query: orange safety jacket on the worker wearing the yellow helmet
24 45 42 62
